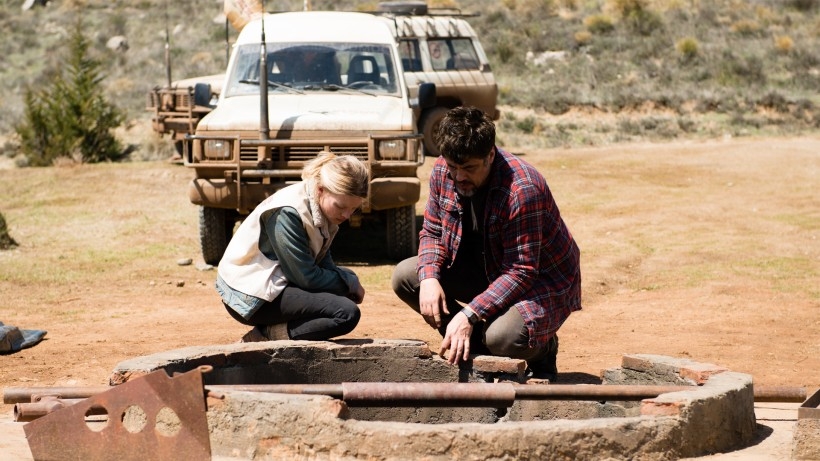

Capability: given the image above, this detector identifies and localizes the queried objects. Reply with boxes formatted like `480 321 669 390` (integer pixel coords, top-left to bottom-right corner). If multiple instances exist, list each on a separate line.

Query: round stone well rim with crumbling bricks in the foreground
110 340 756 461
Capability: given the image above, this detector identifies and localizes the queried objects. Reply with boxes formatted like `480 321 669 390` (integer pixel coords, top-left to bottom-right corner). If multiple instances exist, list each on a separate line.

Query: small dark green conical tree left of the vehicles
16 20 125 166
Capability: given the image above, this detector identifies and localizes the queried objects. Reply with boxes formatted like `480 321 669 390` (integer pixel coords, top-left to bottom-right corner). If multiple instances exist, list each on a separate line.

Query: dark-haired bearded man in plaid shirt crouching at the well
392 107 581 380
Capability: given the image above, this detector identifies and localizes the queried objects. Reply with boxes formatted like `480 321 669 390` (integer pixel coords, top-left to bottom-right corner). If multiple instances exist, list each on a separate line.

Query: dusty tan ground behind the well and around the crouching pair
0 137 820 420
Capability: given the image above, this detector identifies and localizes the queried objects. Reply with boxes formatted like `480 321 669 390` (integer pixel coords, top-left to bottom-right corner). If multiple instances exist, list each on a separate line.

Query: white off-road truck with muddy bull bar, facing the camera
184 11 435 264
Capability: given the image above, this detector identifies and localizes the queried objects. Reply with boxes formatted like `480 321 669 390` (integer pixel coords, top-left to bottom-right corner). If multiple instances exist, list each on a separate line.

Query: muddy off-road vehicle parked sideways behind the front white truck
147 1 500 156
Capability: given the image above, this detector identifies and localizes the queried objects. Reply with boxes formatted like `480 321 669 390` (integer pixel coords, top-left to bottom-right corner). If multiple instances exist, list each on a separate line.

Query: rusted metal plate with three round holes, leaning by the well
23 368 211 461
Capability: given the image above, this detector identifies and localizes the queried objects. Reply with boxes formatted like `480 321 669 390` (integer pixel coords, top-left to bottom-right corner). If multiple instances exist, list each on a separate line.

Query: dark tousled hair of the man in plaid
434 106 495 165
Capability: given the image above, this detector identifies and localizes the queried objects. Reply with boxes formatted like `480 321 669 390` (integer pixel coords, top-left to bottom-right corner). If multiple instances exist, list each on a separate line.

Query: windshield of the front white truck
225 43 399 97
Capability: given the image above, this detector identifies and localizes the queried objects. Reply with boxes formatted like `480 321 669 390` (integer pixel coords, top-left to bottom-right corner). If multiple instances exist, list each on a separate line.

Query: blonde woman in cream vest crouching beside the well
216 153 370 342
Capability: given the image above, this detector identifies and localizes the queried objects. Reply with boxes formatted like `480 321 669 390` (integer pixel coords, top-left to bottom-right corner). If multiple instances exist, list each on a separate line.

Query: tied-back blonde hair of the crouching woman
302 152 370 198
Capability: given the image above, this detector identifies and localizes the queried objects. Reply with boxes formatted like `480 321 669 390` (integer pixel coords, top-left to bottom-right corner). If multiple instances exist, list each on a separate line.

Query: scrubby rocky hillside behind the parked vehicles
0 0 820 153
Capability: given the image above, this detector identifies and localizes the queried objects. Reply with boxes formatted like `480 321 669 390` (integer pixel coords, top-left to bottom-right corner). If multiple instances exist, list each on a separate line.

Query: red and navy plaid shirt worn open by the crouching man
418 148 581 348
